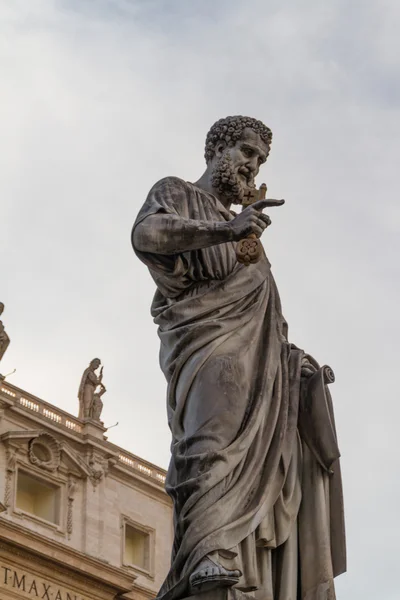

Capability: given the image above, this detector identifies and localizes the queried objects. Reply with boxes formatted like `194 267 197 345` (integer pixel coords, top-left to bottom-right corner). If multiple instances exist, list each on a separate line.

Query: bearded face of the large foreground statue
212 127 268 204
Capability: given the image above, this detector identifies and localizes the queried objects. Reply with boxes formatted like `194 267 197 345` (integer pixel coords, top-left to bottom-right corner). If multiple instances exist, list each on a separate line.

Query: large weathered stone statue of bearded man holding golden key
132 116 346 600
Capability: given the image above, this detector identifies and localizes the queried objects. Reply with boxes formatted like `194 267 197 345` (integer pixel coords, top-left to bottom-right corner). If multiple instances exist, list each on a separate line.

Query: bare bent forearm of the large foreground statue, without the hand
132 213 235 255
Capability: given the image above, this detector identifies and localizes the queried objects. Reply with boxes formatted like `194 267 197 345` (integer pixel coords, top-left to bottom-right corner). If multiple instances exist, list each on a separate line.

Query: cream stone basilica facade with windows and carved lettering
0 380 173 600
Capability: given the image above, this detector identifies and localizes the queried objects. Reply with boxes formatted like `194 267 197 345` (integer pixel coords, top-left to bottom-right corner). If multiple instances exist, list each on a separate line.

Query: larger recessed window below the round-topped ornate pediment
16 470 61 525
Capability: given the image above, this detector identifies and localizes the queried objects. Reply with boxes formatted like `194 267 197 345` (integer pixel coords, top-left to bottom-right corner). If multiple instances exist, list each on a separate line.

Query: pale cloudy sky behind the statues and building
0 0 400 600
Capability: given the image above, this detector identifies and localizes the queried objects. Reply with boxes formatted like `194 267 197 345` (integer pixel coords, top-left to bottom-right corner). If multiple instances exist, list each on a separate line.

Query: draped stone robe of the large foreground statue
132 177 346 600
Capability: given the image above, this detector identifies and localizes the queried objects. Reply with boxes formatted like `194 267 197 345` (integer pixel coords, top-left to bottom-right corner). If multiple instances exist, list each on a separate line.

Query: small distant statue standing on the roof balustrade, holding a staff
78 358 107 421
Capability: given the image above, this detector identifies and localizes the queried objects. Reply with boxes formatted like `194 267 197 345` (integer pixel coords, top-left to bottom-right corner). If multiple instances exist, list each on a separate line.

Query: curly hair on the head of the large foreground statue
204 115 272 163
